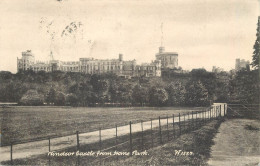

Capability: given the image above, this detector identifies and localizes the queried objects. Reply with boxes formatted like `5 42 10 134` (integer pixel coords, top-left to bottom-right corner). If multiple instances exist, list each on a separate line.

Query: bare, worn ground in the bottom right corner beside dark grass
208 119 260 166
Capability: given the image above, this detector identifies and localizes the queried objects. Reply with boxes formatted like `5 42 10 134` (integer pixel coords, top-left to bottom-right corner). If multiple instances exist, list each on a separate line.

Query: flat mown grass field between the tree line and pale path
0 107 203 145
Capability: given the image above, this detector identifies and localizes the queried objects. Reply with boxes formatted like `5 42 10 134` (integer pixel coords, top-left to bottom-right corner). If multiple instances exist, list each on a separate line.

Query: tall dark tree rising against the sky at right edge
251 16 260 68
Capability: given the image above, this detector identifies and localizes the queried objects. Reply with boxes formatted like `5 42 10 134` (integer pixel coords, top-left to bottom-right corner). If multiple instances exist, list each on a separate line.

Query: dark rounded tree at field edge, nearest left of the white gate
185 80 209 106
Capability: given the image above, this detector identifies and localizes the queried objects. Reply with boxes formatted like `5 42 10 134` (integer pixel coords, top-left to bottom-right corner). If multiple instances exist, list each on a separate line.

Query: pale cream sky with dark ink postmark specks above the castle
0 0 260 73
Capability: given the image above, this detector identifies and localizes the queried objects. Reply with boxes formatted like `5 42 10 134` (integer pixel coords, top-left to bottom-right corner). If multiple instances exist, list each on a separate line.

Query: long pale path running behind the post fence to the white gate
0 103 227 162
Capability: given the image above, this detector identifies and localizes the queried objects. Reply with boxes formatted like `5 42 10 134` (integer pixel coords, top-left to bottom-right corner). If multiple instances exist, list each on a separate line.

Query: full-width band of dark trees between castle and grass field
0 69 259 106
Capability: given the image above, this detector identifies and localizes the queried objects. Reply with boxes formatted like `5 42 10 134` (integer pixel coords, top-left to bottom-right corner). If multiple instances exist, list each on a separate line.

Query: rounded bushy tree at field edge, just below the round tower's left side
149 86 168 106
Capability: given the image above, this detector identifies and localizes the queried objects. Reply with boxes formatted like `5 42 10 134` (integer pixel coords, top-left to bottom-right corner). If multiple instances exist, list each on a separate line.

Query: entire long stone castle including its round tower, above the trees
17 47 178 77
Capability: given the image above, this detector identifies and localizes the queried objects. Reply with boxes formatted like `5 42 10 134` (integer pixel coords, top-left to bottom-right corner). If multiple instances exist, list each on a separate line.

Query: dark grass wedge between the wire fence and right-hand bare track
104 120 221 166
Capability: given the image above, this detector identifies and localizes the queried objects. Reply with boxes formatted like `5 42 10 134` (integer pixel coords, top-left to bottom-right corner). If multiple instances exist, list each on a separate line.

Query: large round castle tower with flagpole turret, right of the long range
155 47 178 69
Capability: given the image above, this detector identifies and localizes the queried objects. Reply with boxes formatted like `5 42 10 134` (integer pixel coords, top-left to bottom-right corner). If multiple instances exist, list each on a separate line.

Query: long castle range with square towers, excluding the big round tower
17 52 161 77
